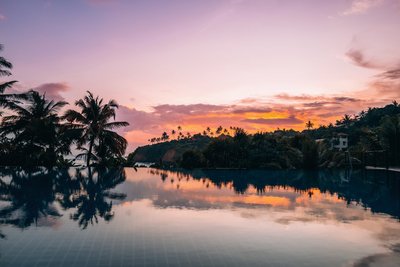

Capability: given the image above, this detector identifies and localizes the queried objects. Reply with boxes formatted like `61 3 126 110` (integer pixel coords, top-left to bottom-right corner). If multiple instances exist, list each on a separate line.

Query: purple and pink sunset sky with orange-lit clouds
0 0 400 152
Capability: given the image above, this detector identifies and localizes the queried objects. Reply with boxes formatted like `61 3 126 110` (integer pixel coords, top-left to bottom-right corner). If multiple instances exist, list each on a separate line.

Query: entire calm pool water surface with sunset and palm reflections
0 168 400 267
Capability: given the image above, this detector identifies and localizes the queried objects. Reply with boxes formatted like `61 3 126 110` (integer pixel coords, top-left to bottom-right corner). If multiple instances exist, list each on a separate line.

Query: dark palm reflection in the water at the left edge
0 169 61 228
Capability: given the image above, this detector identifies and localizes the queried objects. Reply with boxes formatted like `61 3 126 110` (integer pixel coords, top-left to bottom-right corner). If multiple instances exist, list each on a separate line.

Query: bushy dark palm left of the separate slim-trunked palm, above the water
1 90 69 165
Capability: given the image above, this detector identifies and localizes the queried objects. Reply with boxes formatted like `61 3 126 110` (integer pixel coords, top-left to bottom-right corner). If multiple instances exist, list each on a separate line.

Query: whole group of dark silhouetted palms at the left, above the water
0 46 129 166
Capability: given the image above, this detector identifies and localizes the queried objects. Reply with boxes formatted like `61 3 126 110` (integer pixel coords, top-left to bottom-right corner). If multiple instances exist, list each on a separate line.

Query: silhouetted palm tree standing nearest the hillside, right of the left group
63 91 129 167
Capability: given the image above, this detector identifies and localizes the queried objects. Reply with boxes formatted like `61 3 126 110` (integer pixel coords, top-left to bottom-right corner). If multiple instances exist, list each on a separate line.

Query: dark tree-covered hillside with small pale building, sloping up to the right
128 101 400 169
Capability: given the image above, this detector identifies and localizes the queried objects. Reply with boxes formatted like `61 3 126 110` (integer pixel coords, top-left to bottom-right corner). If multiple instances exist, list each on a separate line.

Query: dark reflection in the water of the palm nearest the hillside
61 168 126 229
